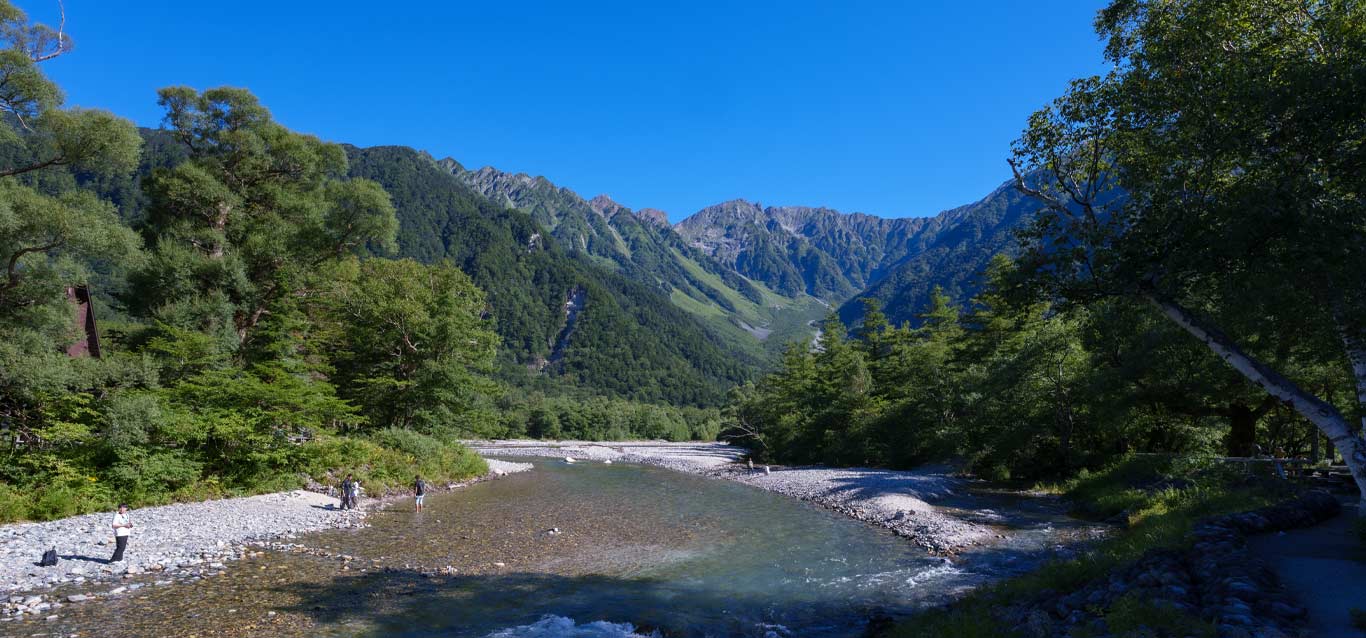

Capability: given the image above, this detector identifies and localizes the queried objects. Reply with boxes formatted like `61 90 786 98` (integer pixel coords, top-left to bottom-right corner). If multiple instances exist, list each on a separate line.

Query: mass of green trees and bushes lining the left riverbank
0 16 496 522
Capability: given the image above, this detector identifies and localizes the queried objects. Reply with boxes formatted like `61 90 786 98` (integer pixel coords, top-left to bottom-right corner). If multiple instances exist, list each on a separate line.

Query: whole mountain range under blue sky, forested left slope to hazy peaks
96 130 1033 404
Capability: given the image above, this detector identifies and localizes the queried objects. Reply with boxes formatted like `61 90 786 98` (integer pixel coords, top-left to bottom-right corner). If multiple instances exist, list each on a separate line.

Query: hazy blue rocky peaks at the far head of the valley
675 184 1033 324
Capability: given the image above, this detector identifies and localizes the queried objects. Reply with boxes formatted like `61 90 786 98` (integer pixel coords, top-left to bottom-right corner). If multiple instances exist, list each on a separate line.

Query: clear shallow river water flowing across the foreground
0 460 1081 637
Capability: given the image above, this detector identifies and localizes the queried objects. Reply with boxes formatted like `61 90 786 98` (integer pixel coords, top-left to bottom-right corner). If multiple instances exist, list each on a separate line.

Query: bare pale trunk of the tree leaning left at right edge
1143 291 1366 518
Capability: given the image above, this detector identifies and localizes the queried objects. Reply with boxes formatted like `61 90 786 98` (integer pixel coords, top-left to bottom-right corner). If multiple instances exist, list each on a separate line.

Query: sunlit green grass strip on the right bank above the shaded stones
891 456 1290 638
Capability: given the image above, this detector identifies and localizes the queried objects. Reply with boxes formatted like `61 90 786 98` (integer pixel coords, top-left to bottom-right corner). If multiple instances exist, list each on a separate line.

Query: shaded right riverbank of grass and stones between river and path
885 459 1340 638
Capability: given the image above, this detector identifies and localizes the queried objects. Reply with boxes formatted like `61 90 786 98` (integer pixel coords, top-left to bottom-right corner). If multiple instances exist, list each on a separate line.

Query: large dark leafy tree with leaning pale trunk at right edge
1011 0 1366 515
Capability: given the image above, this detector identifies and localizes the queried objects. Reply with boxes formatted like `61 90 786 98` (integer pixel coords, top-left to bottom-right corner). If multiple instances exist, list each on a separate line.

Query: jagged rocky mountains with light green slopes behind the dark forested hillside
440 158 1035 334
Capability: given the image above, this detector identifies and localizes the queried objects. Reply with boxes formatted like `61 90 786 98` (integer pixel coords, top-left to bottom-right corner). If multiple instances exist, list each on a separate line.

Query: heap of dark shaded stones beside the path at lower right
997 492 1341 638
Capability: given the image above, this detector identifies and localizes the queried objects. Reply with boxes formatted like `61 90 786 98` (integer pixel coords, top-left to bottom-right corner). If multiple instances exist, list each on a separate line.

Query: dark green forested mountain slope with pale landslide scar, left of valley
337 146 759 404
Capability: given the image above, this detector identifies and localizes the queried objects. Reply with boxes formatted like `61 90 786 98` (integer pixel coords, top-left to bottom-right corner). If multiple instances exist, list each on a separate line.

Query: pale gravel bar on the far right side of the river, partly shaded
466 441 999 553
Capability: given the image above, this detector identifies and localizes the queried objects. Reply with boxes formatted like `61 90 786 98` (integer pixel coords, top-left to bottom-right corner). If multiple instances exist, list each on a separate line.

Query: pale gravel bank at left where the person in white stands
0 459 531 615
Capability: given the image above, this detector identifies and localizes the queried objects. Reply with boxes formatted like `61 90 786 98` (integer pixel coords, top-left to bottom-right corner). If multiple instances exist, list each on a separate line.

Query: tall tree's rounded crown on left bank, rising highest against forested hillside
130 87 398 346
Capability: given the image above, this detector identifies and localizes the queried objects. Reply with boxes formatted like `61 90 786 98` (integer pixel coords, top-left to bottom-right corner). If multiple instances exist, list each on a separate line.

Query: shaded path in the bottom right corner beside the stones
1249 504 1366 638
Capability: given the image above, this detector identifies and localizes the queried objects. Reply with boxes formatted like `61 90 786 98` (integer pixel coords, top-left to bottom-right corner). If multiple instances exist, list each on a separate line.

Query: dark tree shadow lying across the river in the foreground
277 570 891 637
